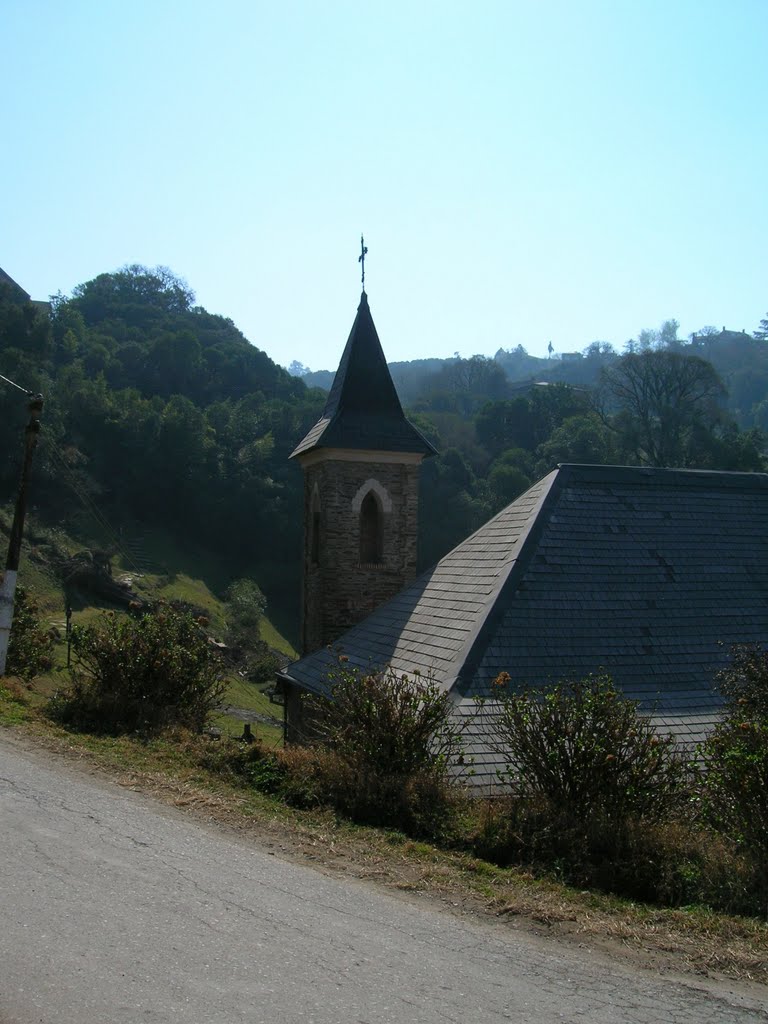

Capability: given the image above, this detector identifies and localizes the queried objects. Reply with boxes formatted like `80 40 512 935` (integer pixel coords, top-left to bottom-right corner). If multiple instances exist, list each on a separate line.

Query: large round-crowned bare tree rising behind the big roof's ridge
600 349 725 466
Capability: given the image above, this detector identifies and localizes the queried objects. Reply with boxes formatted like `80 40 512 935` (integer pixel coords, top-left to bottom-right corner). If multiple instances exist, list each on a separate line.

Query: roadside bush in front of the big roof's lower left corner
296 655 463 838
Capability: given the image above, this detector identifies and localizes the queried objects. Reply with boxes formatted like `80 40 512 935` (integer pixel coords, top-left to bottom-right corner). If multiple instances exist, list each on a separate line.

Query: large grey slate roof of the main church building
284 466 768 783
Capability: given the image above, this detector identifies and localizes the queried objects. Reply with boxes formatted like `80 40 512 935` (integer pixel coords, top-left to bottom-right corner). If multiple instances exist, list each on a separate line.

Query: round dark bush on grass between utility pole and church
50 607 225 735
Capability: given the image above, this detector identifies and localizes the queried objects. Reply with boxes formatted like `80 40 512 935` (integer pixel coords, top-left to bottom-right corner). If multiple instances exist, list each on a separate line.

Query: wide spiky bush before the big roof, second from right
487 673 687 826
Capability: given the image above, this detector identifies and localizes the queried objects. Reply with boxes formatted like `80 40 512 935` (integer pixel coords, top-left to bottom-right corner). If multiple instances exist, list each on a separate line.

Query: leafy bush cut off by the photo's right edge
699 645 768 859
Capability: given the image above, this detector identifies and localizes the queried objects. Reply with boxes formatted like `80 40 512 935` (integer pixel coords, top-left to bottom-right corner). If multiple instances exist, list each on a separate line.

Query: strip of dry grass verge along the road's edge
0 692 768 985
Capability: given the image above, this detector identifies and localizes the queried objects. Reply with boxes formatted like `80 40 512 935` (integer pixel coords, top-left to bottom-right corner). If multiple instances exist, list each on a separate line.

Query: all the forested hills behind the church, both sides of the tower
0 266 768 636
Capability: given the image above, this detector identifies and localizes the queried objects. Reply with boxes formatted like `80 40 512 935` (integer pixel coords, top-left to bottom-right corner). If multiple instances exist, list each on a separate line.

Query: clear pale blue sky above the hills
0 0 768 369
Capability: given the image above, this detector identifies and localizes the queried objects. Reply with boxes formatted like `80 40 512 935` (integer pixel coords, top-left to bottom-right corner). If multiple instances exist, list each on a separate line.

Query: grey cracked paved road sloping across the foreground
0 732 768 1024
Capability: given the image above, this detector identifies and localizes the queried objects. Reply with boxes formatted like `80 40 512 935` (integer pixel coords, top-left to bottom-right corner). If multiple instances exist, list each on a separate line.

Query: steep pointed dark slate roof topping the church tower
291 292 434 459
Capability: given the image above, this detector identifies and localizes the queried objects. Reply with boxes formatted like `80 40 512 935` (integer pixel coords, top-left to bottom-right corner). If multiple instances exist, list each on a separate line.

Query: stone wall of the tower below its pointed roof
302 451 421 654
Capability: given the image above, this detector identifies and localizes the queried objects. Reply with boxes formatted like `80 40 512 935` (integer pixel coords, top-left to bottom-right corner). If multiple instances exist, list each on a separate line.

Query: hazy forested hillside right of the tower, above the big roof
292 321 768 565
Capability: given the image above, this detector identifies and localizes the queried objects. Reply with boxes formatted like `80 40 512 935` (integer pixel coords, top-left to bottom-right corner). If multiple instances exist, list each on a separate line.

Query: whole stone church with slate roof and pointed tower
279 290 768 788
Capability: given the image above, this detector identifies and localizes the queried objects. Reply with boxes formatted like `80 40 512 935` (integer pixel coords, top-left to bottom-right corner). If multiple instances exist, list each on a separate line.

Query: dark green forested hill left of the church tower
0 266 324 630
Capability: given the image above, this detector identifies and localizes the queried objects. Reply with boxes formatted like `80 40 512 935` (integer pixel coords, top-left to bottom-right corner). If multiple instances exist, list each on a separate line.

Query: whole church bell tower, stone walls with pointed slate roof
291 290 434 654
